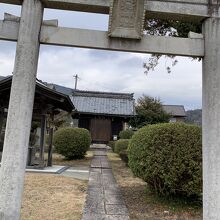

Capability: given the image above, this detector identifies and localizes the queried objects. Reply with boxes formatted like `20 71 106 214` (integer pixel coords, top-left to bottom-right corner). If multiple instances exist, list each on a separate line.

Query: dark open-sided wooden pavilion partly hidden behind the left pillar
0 76 74 167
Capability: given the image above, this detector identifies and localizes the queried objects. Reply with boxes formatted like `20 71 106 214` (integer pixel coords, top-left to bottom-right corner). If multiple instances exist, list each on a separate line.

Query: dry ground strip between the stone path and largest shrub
108 153 202 220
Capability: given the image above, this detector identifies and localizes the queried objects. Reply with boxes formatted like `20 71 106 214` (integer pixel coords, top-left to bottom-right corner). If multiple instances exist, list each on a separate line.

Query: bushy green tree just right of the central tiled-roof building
130 95 170 128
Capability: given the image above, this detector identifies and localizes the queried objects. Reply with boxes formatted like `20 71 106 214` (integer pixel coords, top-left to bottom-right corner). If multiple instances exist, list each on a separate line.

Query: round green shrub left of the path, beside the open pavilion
53 128 91 159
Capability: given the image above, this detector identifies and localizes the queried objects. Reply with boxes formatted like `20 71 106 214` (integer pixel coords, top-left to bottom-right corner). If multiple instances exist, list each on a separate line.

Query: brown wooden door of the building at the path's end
90 118 111 143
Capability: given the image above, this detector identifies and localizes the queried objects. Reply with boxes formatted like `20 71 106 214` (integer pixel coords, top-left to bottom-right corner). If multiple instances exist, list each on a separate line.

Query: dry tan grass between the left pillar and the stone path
21 174 87 220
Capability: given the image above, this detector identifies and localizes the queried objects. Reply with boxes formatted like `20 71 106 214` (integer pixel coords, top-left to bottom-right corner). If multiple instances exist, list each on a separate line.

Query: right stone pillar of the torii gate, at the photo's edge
202 18 220 220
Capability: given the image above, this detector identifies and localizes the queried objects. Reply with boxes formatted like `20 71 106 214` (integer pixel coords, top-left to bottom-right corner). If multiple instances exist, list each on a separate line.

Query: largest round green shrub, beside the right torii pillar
128 123 202 198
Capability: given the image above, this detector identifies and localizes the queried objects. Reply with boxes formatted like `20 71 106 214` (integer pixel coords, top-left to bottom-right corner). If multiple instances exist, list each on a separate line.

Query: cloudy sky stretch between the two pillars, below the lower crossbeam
38 47 202 108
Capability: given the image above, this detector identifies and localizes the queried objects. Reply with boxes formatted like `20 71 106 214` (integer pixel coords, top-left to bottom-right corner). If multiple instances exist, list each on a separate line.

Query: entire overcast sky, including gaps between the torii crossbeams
0 3 202 110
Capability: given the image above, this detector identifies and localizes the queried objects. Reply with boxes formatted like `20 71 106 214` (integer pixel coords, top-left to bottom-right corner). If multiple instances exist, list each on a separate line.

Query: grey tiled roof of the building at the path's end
71 90 134 116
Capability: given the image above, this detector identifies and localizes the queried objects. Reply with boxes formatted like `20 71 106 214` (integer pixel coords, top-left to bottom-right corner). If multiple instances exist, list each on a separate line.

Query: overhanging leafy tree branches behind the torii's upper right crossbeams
143 19 202 74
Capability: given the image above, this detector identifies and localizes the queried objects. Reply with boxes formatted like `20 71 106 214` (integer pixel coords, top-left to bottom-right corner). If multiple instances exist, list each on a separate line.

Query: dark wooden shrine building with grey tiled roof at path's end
71 90 135 143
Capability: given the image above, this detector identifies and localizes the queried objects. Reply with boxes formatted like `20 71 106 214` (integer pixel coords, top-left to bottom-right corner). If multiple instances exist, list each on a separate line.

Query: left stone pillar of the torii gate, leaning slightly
0 0 43 220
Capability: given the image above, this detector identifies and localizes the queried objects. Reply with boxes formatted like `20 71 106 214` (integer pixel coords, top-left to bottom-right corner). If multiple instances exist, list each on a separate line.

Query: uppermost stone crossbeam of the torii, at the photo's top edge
0 0 217 21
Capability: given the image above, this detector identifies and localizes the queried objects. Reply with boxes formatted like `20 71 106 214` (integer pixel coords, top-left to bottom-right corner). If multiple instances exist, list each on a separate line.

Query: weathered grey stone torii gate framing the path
0 0 220 220
